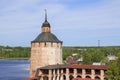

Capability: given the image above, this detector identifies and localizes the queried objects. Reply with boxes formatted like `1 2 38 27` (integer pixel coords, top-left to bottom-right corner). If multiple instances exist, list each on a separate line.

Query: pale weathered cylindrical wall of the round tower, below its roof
30 42 62 77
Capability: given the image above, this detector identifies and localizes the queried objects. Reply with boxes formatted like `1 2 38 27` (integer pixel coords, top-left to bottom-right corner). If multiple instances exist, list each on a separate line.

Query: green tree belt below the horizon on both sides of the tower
0 46 120 80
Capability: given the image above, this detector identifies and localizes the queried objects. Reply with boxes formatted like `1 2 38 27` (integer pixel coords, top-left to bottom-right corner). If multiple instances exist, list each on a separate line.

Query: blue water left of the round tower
0 60 30 80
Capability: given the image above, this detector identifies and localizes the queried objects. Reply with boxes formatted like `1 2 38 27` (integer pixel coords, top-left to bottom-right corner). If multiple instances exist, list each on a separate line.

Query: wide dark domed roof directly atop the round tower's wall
32 33 62 43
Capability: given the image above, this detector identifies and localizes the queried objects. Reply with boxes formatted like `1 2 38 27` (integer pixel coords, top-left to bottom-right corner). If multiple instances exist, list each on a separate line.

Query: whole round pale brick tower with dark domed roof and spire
30 11 62 77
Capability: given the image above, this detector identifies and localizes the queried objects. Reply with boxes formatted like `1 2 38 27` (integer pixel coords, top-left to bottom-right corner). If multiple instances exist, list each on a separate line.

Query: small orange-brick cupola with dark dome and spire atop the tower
42 9 50 32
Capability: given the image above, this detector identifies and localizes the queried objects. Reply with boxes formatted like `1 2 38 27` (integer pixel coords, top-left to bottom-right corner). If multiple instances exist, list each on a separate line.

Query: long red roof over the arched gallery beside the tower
68 64 108 70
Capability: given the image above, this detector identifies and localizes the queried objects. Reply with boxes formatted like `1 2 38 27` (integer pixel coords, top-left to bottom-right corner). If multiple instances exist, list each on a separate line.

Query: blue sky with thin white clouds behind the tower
0 0 120 47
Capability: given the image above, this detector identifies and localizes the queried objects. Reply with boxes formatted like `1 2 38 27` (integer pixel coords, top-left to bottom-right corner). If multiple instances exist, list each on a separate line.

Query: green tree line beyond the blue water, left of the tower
0 46 30 59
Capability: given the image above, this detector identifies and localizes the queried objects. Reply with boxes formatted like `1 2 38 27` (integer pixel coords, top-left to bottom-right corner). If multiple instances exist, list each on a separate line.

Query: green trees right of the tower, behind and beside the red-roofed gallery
63 46 120 80
